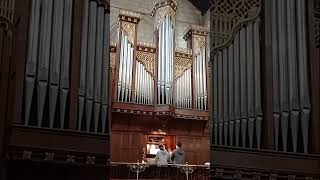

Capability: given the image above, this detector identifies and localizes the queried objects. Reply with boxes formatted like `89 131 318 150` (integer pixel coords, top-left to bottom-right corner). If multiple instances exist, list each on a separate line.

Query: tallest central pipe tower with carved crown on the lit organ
152 1 177 105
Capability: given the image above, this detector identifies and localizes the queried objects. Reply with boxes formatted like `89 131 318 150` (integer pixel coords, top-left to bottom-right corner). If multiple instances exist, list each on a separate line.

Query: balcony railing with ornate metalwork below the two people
110 162 210 180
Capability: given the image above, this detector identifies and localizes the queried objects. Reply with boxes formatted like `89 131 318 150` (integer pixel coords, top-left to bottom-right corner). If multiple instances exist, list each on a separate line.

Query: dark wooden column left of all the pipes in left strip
7 0 31 124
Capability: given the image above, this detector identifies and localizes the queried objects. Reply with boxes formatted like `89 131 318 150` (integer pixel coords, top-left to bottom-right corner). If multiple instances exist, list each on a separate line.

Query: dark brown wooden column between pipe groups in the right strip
260 0 274 149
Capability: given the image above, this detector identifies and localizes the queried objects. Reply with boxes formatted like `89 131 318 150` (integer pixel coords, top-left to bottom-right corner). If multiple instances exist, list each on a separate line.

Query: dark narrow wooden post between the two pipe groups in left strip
68 0 84 130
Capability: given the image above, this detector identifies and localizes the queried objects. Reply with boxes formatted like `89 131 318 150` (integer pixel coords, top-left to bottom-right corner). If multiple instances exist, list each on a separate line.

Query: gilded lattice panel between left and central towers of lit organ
137 51 156 76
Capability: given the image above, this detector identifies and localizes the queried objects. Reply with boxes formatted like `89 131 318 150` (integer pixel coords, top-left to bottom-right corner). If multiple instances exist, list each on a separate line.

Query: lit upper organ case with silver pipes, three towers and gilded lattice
110 0 208 119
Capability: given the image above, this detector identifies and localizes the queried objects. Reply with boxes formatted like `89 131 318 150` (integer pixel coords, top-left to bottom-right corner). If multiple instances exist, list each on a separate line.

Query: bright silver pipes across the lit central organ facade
115 0 208 110
